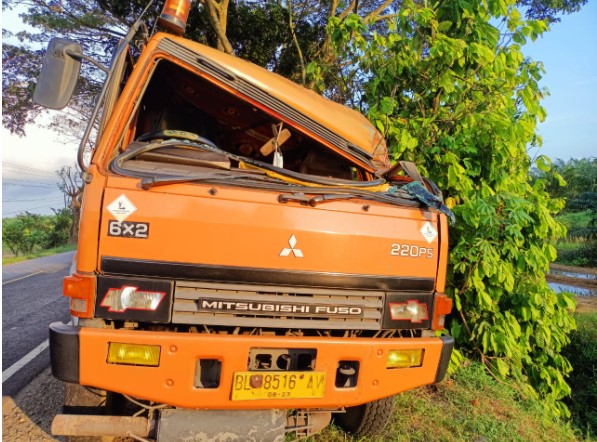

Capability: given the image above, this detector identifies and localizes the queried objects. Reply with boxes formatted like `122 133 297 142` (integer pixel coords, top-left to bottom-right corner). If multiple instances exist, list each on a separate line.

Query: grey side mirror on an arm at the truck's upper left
33 38 83 109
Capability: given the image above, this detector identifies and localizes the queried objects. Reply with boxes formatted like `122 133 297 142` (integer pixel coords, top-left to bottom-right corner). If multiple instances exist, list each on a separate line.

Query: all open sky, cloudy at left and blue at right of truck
1 1 597 217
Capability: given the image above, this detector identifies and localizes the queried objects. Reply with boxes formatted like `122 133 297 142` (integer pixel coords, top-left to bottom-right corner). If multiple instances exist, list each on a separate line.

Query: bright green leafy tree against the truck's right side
310 0 574 420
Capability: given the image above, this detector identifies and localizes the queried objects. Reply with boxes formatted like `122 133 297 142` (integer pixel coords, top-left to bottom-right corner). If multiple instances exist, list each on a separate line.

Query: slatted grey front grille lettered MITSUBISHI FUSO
172 281 385 330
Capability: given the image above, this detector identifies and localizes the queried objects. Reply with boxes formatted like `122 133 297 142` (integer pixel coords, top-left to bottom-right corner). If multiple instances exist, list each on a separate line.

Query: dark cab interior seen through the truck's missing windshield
113 60 365 182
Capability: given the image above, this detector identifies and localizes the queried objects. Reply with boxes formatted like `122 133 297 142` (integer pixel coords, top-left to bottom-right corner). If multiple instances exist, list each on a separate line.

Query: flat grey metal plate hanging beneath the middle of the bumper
157 409 286 442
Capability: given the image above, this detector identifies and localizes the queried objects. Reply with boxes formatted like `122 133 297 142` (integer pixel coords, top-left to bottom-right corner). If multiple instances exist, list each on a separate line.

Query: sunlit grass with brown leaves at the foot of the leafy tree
311 363 581 442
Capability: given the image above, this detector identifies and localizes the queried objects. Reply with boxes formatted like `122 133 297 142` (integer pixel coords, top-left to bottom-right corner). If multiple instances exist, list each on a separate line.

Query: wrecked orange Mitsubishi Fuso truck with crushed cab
34 0 454 441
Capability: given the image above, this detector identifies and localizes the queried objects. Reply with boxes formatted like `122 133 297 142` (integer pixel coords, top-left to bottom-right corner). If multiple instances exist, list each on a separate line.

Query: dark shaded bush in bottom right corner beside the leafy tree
562 313 597 439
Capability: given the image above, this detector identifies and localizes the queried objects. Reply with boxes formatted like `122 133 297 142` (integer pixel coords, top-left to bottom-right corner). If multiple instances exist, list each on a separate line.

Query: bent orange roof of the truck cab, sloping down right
158 33 389 169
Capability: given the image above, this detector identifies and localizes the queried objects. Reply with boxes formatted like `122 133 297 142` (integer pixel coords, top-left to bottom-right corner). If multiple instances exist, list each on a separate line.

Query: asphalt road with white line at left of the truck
2 252 74 396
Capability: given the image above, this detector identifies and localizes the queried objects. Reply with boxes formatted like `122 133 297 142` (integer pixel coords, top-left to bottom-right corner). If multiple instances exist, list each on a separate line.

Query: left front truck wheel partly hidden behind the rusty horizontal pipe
62 382 106 442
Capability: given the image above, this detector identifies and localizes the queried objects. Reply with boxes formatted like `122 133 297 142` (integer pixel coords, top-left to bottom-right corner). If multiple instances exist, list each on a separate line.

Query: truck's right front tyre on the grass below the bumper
334 396 394 437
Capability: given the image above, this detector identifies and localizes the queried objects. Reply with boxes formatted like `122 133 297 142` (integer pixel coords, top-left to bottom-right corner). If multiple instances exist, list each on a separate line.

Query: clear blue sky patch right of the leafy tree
523 0 597 160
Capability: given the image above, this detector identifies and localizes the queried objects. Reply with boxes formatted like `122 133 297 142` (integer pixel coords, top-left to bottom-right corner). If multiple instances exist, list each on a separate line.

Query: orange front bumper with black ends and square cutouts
50 323 454 409
